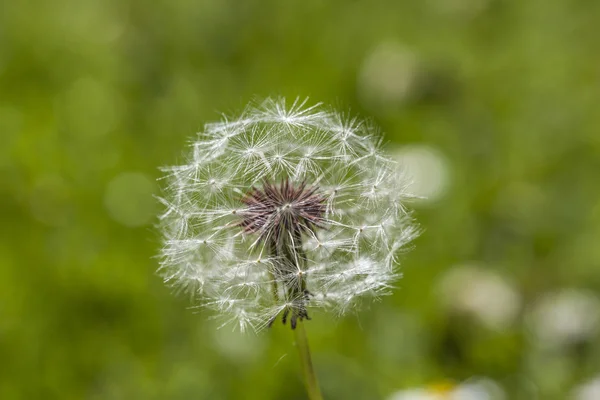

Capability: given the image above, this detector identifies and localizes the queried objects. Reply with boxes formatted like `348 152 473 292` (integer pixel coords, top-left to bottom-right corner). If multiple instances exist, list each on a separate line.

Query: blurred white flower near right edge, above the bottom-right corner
528 289 600 347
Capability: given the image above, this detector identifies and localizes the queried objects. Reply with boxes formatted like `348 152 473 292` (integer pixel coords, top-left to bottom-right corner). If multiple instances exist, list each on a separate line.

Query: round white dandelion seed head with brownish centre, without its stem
159 99 417 330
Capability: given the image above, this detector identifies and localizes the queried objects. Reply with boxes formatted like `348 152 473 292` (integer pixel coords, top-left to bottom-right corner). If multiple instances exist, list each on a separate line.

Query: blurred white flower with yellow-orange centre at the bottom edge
387 378 506 400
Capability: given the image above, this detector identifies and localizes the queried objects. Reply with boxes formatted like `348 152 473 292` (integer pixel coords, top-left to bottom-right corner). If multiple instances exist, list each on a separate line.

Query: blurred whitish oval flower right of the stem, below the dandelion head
439 265 521 330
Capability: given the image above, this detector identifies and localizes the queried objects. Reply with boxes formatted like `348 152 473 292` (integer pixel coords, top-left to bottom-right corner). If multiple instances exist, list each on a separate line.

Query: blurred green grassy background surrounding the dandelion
0 0 600 400
